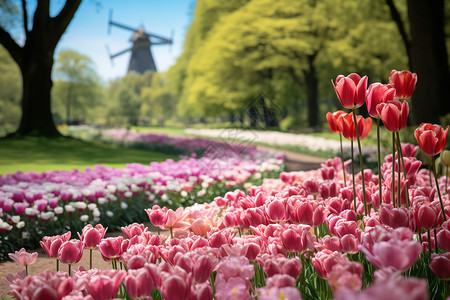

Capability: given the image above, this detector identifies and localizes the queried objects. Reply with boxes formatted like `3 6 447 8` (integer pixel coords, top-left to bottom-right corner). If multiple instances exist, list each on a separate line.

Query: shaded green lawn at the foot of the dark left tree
0 137 177 175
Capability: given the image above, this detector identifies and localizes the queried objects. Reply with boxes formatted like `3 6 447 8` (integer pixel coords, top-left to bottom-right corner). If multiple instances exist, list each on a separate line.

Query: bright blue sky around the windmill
56 0 195 81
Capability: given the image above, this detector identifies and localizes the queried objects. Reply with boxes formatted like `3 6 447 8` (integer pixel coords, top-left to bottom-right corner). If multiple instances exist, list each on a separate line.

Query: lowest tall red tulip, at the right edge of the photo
414 123 448 156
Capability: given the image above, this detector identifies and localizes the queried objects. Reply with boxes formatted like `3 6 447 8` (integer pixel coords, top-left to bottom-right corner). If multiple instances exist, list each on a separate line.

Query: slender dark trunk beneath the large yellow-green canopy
303 54 319 127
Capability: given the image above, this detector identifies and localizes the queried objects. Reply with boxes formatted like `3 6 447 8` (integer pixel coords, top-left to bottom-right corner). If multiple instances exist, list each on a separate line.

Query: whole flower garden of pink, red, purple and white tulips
0 71 450 300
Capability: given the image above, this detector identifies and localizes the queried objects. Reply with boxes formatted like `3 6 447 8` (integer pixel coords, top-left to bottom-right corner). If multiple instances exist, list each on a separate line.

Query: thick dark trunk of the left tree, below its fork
15 45 61 137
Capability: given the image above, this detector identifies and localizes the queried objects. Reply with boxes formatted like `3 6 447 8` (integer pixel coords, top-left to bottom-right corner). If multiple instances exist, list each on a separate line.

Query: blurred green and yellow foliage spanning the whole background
0 0 450 130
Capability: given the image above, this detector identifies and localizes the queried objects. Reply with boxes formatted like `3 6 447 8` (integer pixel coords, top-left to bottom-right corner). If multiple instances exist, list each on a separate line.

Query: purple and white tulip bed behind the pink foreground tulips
0 141 283 261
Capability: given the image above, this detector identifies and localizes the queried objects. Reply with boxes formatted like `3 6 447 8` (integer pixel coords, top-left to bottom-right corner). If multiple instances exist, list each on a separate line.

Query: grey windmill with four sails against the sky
106 10 173 74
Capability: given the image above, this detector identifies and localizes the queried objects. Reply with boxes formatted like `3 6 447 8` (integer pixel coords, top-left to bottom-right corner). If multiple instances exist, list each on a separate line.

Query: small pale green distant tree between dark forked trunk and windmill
52 50 100 124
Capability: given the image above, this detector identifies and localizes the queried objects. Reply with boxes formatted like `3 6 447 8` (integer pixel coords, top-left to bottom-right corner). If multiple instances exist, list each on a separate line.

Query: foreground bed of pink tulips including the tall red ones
5 71 450 300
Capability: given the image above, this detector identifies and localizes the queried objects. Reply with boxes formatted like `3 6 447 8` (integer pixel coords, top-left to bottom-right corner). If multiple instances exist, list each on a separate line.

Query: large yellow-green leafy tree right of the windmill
169 0 406 127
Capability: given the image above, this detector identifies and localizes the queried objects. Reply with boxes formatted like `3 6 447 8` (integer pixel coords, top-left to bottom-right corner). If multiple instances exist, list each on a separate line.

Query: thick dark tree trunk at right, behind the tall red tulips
408 0 450 124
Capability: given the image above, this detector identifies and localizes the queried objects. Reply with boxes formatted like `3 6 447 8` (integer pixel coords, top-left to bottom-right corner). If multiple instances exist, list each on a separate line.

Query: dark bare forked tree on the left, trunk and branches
0 0 81 136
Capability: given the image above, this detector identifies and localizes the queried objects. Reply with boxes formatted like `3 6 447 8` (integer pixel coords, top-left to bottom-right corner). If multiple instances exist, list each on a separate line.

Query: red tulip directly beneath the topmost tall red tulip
377 100 409 132
